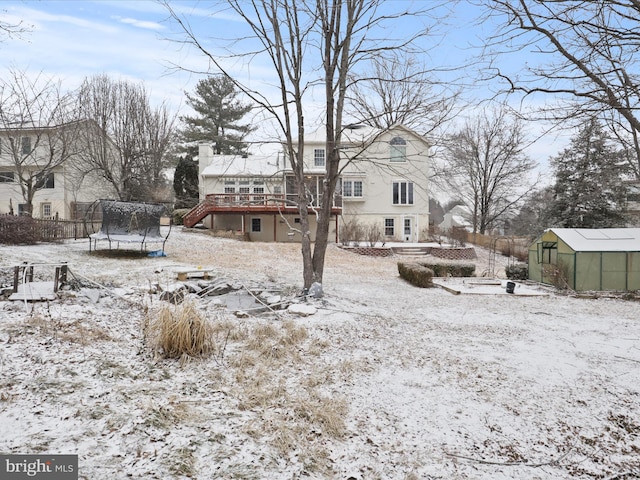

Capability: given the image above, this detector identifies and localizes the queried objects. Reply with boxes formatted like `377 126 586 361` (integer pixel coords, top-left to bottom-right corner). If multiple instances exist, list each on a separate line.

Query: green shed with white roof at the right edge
529 228 640 291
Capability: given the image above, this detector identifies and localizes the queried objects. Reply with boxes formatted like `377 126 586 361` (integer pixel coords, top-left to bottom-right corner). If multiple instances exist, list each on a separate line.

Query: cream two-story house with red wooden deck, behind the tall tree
184 125 430 242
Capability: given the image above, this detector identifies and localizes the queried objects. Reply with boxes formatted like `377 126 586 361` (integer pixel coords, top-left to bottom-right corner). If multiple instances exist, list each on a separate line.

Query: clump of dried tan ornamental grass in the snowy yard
147 302 215 358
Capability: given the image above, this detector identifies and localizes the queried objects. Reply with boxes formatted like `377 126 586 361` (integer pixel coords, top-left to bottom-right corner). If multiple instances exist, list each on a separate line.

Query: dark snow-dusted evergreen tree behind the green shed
548 119 625 228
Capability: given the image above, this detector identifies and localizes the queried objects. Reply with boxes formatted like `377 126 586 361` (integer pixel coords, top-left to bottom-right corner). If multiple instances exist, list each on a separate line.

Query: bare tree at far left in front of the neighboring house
0 70 79 215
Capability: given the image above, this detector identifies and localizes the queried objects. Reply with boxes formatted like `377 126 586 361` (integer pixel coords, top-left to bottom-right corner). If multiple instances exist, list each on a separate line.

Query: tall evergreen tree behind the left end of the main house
179 75 254 157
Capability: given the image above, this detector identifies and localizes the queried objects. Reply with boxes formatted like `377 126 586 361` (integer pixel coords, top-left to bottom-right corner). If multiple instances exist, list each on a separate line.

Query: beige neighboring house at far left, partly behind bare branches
0 122 115 219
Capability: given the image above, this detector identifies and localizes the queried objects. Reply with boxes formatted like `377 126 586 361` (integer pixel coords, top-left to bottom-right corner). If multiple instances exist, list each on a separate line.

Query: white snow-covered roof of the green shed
549 228 640 252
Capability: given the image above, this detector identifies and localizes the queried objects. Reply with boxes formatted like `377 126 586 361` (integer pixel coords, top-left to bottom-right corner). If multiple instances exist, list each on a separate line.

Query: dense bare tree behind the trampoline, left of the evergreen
77 75 175 201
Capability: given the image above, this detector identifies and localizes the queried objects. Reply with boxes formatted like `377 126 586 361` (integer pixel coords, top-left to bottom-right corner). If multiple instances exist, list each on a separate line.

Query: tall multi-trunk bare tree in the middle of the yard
165 0 435 287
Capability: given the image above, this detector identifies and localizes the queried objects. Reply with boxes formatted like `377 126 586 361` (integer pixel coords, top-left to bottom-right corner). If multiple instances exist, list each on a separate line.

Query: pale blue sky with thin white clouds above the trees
0 0 563 176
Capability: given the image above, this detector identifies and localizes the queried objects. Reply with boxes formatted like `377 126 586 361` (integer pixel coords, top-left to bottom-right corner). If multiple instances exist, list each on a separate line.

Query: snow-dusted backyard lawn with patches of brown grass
0 229 640 480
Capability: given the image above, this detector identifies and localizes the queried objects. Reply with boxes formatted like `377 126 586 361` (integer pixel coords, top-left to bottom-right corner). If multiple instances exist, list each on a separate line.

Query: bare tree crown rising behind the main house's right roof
348 50 460 137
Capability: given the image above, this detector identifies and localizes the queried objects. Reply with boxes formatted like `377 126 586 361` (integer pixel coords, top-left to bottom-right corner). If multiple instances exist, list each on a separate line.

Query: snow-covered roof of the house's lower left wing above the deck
202 154 284 177
